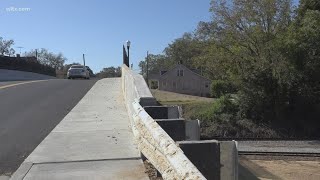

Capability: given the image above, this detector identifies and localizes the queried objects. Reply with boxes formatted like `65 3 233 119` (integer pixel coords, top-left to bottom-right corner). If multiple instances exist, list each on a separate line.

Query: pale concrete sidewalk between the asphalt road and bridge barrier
11 78 149 180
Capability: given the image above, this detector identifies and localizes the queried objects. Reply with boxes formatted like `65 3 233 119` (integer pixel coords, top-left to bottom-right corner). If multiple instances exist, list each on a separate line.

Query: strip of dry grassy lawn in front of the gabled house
151 89 214 105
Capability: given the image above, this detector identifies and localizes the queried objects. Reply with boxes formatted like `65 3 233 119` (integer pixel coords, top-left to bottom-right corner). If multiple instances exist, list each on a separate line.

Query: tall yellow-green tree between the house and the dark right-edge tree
199 0 292 122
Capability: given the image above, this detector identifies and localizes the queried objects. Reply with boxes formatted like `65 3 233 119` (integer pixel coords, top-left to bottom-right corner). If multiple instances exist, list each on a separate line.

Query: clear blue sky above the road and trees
0 0 210 72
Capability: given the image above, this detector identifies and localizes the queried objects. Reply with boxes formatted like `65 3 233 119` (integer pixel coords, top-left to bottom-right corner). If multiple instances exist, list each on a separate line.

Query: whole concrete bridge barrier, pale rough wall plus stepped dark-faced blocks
122 65 238 180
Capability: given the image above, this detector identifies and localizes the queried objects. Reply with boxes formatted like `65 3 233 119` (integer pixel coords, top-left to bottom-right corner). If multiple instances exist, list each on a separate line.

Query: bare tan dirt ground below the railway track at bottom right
239 156 320 180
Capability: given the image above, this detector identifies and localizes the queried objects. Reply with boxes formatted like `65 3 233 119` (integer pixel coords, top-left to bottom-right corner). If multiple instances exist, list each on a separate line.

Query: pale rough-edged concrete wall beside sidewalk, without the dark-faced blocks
122 65 206 180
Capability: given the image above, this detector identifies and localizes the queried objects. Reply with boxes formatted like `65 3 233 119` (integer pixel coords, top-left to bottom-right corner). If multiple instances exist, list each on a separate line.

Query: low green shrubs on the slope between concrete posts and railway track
183 95 279 139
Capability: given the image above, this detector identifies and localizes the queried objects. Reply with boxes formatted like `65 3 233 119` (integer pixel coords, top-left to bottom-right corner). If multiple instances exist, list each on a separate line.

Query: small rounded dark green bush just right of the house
211 80 235 98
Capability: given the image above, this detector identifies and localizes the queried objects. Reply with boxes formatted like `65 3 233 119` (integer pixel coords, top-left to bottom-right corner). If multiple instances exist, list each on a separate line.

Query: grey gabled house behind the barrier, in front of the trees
149 64 211 96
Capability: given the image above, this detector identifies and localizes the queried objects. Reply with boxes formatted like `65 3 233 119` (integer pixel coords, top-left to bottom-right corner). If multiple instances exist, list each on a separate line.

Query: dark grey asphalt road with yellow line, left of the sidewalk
0 79 96 175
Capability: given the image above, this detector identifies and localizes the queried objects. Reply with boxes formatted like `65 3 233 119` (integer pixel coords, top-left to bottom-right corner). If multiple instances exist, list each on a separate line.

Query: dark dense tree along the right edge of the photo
281 0 320 135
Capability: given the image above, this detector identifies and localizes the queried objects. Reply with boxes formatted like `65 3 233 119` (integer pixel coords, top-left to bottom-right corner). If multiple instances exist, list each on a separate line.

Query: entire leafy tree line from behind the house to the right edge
134 0 320 136
